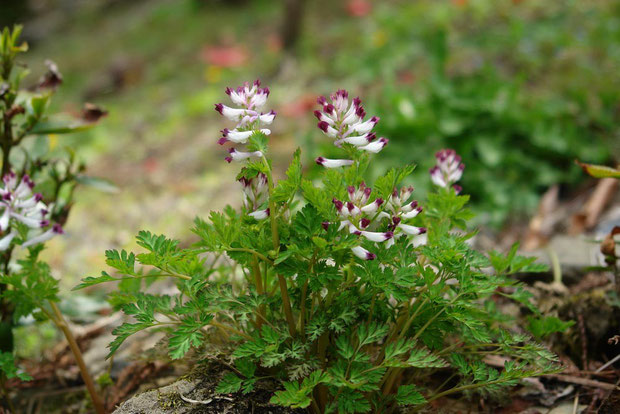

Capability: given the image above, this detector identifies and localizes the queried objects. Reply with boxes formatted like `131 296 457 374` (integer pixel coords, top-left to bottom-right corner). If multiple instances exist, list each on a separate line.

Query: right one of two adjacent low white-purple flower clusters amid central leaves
380 187 426 247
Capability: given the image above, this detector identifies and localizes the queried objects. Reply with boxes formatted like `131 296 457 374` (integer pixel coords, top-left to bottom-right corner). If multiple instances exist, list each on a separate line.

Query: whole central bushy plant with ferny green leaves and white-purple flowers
85 81 557 413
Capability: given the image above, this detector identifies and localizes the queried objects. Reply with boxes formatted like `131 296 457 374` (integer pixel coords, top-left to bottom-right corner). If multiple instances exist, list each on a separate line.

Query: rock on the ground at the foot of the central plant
113 363 306 414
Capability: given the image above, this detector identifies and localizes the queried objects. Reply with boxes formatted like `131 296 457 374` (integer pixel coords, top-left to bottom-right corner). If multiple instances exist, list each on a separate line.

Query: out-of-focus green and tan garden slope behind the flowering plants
0 0 620 294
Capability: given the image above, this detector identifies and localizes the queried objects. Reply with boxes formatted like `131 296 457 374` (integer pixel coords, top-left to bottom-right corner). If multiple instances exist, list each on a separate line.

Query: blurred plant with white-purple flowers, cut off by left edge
0 26 104 413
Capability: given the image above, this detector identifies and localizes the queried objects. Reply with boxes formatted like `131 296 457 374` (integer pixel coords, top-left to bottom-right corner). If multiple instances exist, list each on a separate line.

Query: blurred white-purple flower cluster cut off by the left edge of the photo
0 172 63 251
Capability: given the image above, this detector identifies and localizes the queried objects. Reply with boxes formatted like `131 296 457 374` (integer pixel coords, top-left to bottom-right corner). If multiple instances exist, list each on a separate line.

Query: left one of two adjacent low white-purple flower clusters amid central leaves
324 182 394 260
